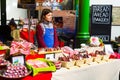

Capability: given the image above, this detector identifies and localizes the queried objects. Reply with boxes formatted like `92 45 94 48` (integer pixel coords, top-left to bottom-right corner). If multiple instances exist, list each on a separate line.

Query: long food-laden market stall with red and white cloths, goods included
0 37 120 80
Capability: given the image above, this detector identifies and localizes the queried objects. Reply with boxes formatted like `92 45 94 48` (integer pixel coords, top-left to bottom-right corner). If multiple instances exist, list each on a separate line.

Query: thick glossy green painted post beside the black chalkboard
75 0 90 48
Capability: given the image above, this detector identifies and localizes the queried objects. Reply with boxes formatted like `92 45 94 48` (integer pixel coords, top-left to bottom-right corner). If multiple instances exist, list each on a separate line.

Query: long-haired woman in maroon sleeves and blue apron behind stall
36 9 59 48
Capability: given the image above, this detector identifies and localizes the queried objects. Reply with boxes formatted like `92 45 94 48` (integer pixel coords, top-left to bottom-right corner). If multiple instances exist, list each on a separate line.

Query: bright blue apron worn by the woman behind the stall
44 28 54 48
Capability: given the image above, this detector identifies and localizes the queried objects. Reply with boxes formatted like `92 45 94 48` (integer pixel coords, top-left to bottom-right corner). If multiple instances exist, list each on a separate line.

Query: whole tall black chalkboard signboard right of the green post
90 5 112 43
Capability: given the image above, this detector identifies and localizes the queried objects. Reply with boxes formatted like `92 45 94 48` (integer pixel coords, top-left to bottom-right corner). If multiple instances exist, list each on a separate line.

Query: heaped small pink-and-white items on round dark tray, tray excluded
2 64 28 78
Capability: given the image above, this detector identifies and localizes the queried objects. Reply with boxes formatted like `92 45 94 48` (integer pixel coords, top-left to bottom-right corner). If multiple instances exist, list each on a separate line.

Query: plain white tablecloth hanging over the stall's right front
51 59 120 80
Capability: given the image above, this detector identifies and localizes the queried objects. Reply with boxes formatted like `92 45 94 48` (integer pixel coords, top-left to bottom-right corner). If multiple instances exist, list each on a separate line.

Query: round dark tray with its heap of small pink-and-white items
0 64 31 80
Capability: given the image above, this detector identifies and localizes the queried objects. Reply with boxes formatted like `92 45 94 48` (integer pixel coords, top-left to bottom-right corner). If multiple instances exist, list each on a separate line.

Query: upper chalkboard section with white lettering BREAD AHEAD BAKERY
92 5 112 24
